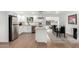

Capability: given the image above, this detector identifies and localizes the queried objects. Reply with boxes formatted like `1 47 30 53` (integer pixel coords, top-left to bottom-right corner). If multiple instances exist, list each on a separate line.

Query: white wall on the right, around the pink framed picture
60 11 79 37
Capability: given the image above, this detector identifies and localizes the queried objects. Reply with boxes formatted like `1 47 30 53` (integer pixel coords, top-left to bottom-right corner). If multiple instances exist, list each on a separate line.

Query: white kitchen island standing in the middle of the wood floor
35 27 50 43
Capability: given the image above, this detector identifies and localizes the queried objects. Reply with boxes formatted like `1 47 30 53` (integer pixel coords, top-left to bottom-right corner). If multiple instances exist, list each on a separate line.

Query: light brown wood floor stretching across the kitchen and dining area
9 33 79 48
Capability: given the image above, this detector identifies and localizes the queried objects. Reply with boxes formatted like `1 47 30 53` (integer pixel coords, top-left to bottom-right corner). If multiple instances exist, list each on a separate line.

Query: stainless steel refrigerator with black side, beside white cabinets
9 15 19 41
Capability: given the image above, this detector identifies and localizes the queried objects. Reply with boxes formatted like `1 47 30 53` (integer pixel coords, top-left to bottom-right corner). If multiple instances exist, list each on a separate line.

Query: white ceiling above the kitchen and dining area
10 11 76 16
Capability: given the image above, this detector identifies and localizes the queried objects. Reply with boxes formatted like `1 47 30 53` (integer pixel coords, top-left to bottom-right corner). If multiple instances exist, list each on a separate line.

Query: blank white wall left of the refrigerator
0 11 9 42
